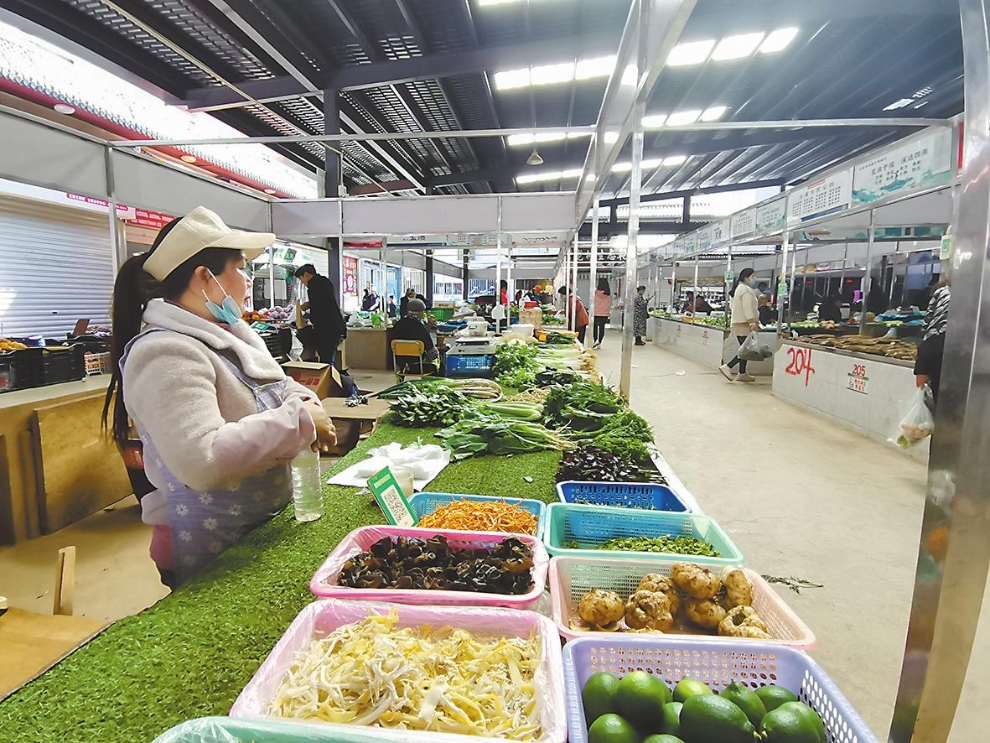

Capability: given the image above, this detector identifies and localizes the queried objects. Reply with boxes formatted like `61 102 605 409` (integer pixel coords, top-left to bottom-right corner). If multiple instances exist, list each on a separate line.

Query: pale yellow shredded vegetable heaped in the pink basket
269 609 541 741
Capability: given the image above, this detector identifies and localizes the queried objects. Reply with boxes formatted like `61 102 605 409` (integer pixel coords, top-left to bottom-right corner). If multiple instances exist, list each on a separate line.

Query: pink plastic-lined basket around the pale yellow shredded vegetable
230 592 567 743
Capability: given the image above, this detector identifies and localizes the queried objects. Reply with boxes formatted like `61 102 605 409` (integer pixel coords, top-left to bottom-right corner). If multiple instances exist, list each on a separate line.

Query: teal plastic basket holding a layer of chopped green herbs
543 503 743 567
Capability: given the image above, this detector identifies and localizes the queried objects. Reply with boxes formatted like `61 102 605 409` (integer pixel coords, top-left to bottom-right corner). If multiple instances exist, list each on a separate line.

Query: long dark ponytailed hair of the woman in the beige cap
102 217 241 446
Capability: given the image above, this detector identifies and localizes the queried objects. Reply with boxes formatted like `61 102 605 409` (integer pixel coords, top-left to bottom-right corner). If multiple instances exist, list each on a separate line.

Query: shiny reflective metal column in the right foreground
889 0 990 743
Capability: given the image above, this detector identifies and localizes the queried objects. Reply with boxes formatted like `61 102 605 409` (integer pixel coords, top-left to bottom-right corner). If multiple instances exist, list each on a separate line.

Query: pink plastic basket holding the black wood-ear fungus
309 526 550 609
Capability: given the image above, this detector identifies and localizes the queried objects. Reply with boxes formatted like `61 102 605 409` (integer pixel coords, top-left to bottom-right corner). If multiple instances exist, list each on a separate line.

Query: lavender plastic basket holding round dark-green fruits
564 636 878 743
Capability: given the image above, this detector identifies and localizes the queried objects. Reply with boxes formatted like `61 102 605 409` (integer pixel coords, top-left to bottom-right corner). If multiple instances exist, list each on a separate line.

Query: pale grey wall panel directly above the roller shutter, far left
0 114 107 198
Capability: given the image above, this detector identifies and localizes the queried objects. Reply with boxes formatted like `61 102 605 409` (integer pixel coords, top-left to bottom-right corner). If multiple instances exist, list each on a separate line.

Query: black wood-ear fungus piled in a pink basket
337 535 533 596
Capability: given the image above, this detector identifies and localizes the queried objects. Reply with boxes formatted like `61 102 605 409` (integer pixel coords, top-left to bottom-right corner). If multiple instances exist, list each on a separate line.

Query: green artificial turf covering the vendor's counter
0 424 560 743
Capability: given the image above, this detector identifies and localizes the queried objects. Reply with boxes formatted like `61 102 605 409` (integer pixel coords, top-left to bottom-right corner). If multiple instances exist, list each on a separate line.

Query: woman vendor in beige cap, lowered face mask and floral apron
103 206 335 587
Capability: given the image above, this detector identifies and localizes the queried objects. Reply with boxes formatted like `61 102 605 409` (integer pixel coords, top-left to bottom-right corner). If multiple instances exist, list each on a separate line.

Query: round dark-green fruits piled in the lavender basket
581 670 827 743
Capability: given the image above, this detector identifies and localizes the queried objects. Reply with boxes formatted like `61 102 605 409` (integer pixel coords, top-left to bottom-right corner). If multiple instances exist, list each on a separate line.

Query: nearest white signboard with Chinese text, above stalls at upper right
852 129 952 205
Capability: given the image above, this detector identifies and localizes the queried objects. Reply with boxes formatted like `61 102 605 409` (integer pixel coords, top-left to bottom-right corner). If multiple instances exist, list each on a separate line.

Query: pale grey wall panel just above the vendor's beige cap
111 151 270 232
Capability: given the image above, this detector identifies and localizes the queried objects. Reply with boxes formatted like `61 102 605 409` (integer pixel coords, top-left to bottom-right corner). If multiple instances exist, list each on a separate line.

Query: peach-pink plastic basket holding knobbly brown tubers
547 557 817 650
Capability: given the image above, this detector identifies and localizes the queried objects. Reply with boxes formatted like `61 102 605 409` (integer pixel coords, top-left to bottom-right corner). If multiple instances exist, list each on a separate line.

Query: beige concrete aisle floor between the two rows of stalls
599 332 990 743
